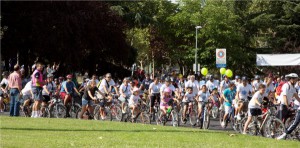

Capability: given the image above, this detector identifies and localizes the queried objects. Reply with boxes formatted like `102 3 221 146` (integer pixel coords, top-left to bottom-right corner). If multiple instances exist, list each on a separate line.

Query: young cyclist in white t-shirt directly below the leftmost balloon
196 85 212 123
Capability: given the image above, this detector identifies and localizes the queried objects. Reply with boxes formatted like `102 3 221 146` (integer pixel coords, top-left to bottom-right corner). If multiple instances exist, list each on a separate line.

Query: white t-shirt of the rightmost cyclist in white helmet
279 83 297 104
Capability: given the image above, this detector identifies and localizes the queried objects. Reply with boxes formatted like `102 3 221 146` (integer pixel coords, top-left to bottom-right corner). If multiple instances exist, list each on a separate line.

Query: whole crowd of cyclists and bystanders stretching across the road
0 63 300 140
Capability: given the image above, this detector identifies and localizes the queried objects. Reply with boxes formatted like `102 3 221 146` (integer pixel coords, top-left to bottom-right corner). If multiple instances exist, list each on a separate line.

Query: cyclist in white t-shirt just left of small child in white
119 78 131 114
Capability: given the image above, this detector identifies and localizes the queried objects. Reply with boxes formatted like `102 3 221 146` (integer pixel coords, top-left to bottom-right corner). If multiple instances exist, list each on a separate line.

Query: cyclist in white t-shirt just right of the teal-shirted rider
234 76 253 120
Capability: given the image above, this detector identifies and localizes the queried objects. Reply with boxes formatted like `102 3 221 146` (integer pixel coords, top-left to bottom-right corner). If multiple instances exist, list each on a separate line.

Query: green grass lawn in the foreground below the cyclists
0 116 300 148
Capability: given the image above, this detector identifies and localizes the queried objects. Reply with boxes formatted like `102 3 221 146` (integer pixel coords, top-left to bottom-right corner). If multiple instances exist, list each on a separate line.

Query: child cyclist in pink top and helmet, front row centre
160 87 173 118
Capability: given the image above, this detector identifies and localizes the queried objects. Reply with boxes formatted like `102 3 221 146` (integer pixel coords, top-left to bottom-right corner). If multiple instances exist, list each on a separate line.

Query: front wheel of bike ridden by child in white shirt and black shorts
265 117 285 138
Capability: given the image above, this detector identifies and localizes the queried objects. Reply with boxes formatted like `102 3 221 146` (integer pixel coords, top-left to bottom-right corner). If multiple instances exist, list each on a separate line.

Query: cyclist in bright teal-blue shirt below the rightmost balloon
221 82 236 128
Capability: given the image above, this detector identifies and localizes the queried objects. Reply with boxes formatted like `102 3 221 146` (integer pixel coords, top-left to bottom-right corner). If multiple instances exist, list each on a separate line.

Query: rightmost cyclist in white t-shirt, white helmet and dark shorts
277 73 300 140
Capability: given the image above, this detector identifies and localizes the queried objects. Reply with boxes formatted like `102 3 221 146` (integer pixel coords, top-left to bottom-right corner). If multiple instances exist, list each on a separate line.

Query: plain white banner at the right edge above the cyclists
256 54 300 66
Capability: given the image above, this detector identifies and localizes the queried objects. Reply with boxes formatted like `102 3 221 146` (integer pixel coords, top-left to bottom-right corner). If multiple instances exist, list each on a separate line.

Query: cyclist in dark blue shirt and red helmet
60 74 80 117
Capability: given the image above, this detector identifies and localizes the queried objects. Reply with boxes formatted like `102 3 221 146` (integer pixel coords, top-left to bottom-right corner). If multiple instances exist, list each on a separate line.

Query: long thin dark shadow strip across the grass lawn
0 127 224 134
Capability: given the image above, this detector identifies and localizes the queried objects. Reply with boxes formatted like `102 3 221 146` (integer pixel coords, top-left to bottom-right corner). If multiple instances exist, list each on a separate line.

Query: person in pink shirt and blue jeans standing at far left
8 65 22 116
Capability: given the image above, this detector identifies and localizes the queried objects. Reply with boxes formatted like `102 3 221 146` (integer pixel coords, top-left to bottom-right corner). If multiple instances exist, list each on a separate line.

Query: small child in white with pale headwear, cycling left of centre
129 87 141 119
